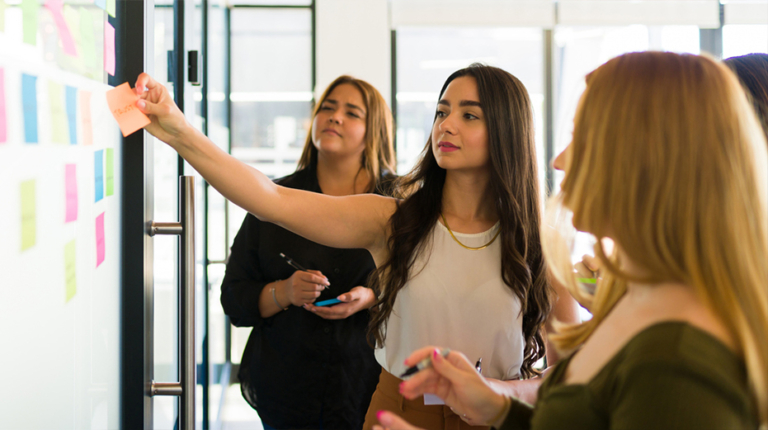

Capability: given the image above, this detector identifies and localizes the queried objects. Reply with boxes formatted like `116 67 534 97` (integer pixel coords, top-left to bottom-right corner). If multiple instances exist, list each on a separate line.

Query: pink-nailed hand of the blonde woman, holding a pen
400 346 506 425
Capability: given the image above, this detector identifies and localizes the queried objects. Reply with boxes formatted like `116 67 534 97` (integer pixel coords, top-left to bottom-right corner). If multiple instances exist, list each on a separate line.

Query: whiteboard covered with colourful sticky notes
0 0 122 430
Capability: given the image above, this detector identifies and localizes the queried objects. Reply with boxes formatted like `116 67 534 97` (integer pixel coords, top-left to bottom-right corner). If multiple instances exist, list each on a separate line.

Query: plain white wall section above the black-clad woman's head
314 0 391 105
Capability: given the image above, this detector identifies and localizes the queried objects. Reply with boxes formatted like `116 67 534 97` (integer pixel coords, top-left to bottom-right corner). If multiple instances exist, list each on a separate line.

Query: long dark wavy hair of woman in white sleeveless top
369 64 552 378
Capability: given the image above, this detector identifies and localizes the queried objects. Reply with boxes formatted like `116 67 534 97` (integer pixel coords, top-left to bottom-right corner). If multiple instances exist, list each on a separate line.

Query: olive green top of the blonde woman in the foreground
500 322 758 430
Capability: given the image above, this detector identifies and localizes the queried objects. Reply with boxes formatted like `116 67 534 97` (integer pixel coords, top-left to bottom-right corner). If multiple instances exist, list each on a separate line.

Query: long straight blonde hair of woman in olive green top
544 52 768 426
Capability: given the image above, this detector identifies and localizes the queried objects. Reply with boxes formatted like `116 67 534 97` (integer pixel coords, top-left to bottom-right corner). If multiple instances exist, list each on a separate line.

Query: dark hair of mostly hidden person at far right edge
723 54 768 139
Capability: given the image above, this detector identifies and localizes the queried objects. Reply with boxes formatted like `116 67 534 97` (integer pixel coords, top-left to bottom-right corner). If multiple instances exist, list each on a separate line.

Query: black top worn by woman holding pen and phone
221 168 392 429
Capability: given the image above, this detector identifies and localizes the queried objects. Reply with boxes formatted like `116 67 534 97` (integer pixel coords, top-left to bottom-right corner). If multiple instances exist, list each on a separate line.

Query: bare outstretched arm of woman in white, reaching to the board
136 73 396 264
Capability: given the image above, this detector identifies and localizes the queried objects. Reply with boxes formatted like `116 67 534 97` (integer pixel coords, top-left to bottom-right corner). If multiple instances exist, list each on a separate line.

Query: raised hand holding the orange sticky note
134 73 192 146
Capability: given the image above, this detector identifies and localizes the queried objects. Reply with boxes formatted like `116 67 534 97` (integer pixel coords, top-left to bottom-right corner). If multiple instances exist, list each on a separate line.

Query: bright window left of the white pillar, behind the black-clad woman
231 8 312 177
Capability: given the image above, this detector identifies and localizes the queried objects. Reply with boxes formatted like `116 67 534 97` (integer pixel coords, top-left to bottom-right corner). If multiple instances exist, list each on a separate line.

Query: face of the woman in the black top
312 84 367 157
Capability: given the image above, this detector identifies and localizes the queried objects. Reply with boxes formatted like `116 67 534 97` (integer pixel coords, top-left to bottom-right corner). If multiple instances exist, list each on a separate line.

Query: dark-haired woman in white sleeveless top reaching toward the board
136 65 576 428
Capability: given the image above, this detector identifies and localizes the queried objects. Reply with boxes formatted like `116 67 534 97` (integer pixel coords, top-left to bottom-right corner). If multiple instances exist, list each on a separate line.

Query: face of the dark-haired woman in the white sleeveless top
432 76 490 170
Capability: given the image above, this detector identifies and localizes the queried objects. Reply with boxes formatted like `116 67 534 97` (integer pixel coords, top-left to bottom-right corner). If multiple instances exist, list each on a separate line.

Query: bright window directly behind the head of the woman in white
396 27 544 184
